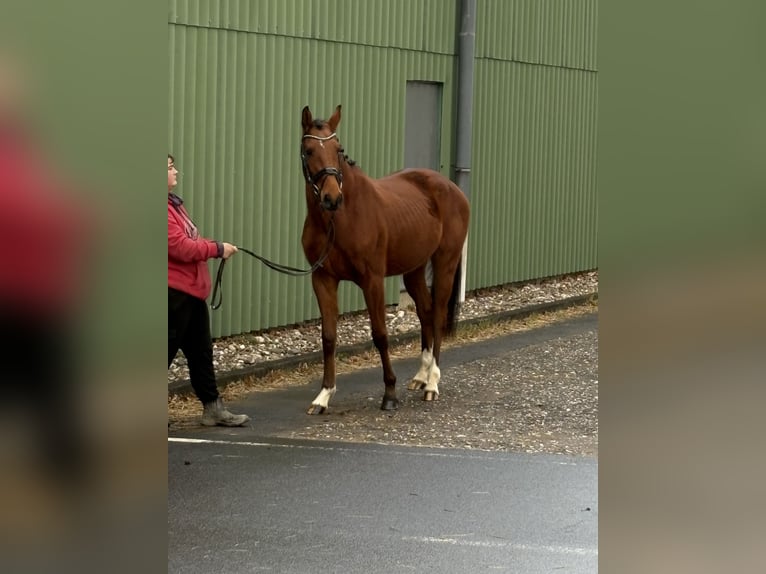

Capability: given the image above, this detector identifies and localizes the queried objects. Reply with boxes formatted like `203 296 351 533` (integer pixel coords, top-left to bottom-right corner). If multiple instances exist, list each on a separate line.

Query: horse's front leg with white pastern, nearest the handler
306 270 338 415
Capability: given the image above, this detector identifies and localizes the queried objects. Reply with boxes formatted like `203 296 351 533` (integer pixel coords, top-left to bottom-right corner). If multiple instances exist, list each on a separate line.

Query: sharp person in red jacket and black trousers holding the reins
168 154 250 427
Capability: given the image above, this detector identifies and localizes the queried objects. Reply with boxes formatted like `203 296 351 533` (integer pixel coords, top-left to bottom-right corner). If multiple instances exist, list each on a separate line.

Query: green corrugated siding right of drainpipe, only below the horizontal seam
469 55 597 288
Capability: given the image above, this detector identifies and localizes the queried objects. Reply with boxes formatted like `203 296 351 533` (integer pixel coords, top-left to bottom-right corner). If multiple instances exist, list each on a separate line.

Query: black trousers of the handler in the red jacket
168 287 218 404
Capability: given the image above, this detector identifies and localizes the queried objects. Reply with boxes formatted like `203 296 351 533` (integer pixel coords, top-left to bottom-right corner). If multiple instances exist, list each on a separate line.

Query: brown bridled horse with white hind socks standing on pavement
301 106 470 414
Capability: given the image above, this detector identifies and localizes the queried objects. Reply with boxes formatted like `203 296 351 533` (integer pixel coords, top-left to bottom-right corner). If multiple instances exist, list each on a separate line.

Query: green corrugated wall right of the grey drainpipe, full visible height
474 0 598 289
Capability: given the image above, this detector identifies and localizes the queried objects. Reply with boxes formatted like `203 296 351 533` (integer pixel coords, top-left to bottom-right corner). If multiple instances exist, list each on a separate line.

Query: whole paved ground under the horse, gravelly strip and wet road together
168 313 598 574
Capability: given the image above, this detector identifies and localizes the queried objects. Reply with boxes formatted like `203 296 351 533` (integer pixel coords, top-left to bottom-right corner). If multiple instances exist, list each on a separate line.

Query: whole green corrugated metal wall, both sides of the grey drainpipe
168 0 596 336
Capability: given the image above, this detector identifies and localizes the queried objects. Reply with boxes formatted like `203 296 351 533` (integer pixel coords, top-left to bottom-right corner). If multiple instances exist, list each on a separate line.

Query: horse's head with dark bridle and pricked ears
301 106 343 211
